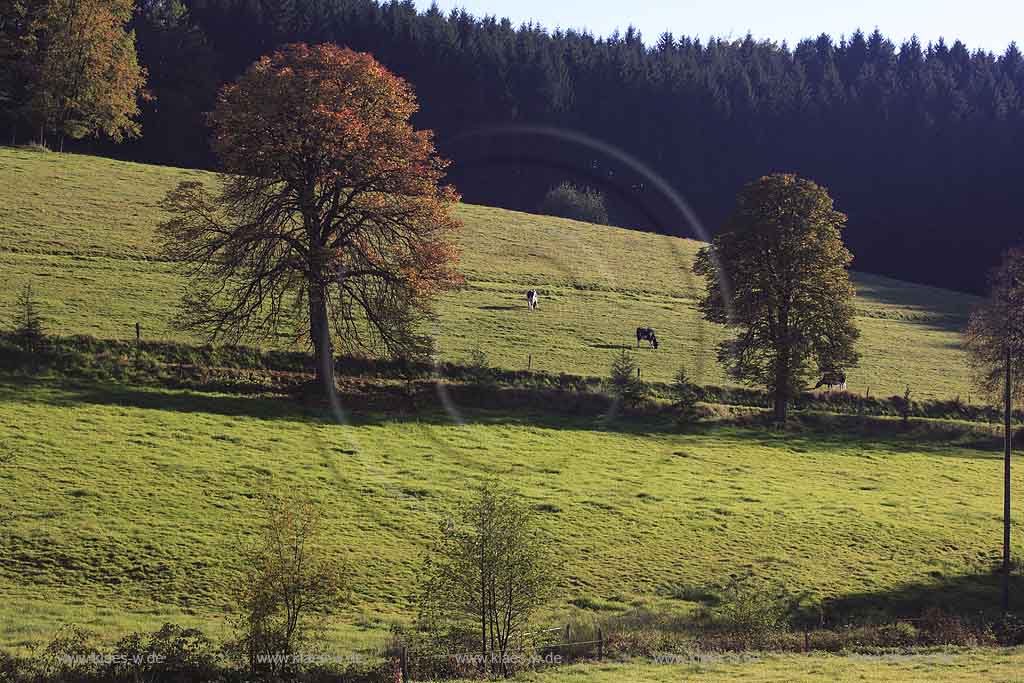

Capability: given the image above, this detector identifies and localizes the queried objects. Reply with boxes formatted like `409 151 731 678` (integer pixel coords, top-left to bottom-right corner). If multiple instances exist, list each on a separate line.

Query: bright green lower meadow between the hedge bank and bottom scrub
0 382 1024 644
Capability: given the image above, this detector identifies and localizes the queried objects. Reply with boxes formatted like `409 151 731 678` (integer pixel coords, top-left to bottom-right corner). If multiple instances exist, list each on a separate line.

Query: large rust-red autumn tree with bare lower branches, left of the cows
161 44 461 393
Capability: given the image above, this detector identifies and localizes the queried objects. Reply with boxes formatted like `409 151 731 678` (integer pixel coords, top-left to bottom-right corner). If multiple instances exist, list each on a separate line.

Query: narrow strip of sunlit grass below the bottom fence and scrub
479 648 1024 683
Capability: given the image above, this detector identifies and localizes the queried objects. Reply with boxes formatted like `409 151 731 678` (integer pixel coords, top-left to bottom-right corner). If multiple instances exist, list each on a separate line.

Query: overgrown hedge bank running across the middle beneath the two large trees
0 335 1011 422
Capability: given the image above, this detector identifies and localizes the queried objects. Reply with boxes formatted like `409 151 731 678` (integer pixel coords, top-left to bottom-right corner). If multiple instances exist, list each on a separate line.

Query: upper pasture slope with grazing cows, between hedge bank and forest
0 148 973 399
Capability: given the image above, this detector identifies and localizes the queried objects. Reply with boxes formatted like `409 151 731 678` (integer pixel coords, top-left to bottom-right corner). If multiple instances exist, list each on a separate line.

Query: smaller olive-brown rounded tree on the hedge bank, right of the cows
693 173 859 422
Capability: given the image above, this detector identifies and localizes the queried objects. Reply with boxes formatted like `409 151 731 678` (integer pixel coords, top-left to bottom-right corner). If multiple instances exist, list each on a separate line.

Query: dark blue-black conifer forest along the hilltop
14 0 1024 290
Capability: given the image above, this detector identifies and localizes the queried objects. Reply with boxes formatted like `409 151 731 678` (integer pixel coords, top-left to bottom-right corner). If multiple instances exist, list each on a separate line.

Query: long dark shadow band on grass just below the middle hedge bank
0 377 1001 459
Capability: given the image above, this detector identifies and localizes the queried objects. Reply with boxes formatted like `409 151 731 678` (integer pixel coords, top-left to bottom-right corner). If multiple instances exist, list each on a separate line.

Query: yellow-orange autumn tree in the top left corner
30 0 145 145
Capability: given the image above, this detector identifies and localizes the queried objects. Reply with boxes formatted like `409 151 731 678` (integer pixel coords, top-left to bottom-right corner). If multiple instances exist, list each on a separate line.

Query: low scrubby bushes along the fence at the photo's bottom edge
0 609 1024 683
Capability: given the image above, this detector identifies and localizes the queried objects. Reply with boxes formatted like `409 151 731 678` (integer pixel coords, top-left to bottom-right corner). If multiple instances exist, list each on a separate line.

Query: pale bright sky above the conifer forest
416 0 1024 53
